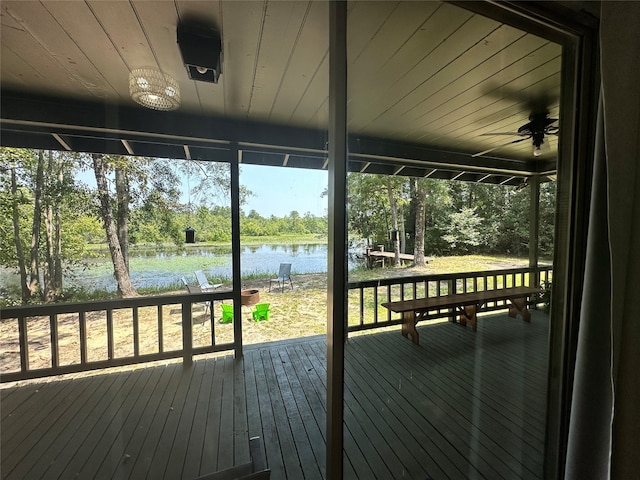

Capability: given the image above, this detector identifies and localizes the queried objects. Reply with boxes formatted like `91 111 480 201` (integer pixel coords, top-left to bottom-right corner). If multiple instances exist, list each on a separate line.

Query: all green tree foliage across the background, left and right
0 148 555 304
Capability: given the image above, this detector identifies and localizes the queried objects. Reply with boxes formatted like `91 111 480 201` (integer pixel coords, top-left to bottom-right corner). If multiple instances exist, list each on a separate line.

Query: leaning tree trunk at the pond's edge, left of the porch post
92 154 138 297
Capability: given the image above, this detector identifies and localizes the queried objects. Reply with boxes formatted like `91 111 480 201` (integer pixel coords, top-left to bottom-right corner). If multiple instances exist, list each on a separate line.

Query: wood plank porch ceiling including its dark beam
0 0 562 183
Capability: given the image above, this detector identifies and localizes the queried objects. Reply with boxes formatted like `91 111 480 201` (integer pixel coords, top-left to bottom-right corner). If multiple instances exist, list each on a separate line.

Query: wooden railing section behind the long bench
347 266 553 332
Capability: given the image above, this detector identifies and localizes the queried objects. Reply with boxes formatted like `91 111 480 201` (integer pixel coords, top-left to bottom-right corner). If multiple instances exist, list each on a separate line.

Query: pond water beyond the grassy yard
0 244 357 291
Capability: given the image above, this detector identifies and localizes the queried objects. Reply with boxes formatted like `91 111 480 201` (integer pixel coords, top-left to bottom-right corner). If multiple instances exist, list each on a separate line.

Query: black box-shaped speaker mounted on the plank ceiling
177 24 222 83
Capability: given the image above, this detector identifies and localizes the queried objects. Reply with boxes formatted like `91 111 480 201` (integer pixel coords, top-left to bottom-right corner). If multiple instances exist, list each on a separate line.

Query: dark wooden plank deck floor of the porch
0 312 548 480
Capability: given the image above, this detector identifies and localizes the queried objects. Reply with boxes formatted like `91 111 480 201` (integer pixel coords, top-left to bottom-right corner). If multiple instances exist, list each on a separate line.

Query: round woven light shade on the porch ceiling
129 68 180 111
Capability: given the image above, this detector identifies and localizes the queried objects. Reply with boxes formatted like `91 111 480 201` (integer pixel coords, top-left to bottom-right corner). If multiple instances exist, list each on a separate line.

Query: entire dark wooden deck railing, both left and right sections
0 266 552 382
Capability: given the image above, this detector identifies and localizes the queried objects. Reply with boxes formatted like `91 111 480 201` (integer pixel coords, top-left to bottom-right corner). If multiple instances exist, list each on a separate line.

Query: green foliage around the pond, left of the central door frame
0 148 328 303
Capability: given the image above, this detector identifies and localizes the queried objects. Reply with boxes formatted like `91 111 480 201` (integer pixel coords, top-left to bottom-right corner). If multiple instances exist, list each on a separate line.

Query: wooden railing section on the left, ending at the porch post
0 291 235 382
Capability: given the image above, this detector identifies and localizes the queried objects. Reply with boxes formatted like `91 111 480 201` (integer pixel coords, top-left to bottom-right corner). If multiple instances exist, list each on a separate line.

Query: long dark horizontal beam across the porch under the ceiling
0 91 555 185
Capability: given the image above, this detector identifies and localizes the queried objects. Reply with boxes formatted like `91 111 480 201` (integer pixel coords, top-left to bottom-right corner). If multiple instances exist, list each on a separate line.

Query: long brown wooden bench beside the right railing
382 287 542 344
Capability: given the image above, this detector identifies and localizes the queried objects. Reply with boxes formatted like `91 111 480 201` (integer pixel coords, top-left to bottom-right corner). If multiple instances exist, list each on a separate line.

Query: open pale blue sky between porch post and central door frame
240 165 328 218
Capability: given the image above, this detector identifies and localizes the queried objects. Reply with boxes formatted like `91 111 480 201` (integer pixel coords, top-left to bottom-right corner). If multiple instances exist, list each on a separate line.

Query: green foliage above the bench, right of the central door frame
348 173 555 257
